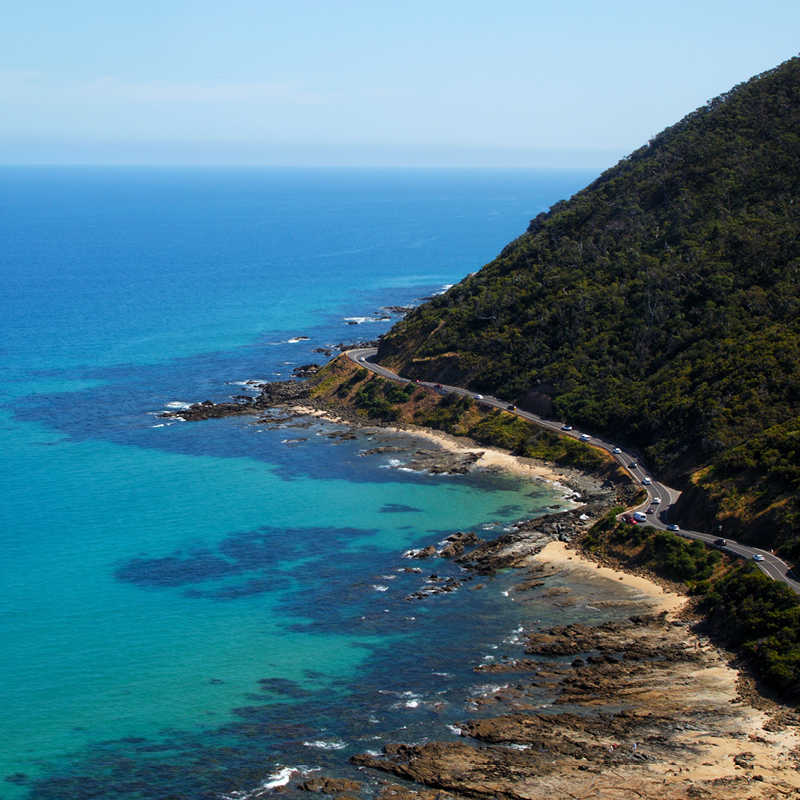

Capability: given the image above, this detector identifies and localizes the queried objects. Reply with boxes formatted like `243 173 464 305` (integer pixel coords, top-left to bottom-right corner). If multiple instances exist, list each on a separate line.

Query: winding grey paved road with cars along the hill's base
347 347 800 594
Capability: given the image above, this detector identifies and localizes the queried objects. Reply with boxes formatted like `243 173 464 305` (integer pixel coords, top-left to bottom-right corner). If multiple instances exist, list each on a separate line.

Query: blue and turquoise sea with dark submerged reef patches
0 167 620 800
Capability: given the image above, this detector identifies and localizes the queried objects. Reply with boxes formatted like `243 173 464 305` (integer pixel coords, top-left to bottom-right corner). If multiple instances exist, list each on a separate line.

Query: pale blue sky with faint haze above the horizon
0 0 800 168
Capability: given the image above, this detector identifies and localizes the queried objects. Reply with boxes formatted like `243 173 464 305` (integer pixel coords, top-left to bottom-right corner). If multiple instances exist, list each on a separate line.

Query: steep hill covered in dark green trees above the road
377 58 800 551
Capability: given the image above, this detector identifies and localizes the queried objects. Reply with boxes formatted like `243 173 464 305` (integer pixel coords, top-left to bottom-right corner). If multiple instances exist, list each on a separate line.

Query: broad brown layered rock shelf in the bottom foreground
351 614 800 800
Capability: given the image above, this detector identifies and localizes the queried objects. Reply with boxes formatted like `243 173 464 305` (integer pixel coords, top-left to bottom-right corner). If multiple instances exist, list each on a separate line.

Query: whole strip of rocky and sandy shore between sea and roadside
161 358 800 800
